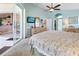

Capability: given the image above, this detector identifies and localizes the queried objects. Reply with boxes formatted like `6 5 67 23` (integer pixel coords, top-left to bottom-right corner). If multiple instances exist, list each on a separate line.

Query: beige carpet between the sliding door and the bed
1 38 32 56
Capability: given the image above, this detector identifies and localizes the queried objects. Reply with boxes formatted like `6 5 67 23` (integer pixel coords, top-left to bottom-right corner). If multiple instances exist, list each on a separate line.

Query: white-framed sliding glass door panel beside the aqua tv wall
13 4 25 44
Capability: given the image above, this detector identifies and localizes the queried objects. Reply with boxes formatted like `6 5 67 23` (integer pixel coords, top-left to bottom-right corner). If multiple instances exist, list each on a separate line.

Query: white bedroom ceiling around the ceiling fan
34 3 79 10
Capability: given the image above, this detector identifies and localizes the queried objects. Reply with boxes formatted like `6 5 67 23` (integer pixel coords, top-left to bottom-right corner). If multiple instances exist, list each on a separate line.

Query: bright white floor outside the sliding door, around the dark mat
0 33 13 49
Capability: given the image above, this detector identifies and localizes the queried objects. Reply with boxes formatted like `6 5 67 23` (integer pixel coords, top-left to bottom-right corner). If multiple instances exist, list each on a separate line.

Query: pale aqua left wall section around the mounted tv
22 3 48 26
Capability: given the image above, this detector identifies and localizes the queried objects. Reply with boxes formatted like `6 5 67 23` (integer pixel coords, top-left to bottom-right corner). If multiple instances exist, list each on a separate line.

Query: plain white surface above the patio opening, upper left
0 3 15 13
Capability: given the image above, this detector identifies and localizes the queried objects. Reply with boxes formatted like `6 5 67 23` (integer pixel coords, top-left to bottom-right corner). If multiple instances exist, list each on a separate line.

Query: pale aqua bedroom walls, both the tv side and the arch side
22 3 79 28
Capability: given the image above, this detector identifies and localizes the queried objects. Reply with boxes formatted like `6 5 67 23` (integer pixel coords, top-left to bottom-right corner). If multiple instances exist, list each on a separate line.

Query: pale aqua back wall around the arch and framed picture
48 10 79 28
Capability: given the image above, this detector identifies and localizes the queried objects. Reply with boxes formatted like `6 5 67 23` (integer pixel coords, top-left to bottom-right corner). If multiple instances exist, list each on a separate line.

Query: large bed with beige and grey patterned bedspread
29 31 79 56
